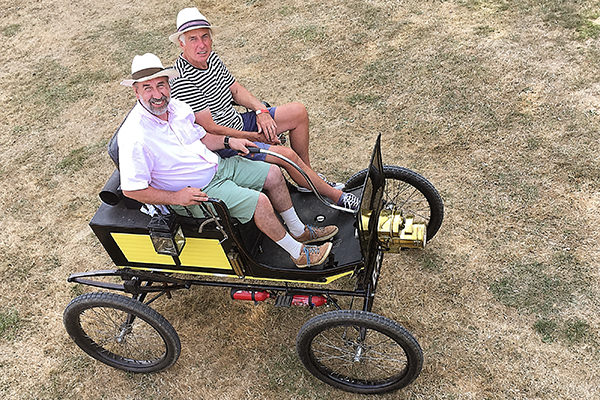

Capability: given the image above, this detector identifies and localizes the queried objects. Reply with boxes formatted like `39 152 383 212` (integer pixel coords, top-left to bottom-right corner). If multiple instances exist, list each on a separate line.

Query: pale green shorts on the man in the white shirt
172 156 271 224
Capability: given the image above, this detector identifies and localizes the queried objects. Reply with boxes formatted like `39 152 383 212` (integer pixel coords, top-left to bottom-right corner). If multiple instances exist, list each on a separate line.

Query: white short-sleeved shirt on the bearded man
117 98 219 192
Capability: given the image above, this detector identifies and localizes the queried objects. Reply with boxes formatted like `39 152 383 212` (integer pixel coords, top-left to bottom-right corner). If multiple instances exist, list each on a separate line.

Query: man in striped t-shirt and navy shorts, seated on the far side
169 7 358 210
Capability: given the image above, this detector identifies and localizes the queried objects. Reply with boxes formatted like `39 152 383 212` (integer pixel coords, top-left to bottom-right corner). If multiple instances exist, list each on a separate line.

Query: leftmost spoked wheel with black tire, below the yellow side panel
63 293 181 372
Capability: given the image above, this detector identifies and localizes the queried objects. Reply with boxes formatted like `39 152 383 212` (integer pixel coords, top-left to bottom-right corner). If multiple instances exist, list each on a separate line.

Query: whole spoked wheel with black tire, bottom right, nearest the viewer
296 310 423 394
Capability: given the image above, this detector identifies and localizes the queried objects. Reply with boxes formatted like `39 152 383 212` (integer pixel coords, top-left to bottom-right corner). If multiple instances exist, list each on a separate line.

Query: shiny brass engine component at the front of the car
362 210 427 253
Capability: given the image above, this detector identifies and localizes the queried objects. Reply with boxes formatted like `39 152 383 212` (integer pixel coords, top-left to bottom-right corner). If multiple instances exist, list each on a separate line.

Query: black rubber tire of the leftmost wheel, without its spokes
63 293 181 373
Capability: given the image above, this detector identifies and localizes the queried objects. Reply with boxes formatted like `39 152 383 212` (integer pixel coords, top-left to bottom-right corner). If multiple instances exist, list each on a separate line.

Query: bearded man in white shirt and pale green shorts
117 53 338 268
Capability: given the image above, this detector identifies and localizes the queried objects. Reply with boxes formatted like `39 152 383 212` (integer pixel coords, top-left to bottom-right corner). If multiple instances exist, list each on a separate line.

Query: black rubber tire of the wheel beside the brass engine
344 165 444 241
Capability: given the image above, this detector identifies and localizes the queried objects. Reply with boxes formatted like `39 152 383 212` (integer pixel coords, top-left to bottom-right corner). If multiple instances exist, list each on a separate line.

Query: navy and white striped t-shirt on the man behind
170 52 244 130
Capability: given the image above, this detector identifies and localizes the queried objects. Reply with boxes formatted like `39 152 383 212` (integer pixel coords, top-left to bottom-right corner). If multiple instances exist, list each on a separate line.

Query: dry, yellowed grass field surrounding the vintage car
0 0 600 400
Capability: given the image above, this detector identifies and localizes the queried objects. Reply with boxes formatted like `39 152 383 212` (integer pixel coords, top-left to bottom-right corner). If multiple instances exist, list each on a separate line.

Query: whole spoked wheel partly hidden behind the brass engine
344 165 444 240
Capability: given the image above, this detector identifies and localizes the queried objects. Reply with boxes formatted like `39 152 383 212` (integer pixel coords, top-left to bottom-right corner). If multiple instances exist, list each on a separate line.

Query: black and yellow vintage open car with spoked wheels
63 137 444 393
